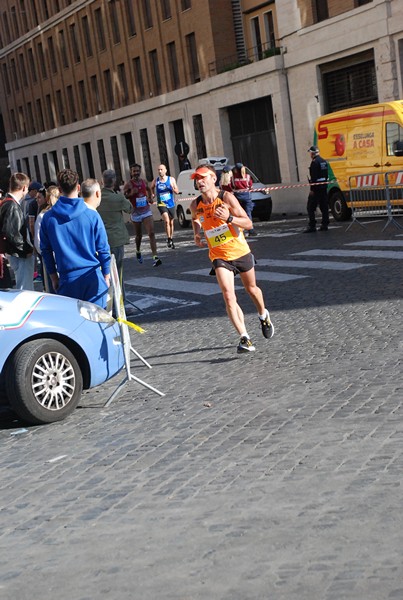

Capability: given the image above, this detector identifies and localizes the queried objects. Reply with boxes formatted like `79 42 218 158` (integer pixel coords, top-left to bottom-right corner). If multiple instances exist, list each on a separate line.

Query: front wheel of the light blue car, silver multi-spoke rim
6 339 83 424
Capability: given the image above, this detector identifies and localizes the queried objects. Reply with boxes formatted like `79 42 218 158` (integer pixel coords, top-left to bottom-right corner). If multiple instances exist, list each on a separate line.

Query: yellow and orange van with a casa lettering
314 100 403 221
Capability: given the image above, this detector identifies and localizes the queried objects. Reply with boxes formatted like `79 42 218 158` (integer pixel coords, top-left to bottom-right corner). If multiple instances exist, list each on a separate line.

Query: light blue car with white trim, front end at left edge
0 290 124 424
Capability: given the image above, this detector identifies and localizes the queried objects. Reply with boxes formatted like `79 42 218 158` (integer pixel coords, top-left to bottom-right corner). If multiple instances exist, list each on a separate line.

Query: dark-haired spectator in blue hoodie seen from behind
41 169 111 308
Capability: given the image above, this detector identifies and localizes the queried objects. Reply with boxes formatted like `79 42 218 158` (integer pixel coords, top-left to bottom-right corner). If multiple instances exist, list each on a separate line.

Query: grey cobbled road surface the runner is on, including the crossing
0 219 403 600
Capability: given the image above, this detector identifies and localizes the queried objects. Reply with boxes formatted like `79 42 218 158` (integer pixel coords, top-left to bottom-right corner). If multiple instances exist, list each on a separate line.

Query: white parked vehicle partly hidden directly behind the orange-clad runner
176 157 273 227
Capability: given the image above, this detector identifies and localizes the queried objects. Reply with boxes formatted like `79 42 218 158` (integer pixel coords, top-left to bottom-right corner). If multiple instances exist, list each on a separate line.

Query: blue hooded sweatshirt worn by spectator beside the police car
41 196 111 283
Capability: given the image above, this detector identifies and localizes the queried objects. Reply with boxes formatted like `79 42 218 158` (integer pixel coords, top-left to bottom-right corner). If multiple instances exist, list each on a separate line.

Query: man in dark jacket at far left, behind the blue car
0 173 34 290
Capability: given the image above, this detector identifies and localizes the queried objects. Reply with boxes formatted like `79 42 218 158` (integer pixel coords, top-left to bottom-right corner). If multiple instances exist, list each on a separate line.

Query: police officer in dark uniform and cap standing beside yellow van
304 146 329 233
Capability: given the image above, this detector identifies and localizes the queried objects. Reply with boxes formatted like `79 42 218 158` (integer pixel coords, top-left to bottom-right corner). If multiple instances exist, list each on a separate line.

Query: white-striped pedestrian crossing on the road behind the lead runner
125 238 403 314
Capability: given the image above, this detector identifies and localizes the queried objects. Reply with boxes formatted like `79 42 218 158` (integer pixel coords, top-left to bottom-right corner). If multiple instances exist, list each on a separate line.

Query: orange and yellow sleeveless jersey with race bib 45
196 198 250 261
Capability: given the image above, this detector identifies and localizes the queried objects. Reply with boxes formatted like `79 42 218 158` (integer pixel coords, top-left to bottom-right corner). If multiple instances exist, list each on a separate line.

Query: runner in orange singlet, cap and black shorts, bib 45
190 165 274 353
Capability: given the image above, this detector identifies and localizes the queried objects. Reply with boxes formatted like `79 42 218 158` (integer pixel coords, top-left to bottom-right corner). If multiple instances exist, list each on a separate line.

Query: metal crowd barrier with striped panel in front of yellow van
346 171 403 231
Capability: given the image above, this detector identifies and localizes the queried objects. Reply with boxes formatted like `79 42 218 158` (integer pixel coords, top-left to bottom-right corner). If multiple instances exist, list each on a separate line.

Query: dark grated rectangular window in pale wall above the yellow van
323 60 378 112
